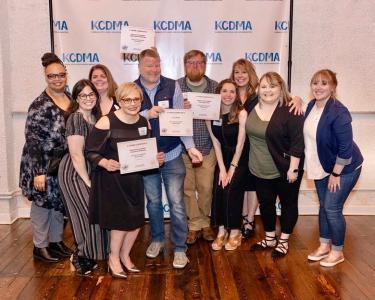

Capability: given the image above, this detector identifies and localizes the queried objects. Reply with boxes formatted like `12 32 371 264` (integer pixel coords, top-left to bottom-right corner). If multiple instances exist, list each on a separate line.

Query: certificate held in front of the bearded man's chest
185 92 221 120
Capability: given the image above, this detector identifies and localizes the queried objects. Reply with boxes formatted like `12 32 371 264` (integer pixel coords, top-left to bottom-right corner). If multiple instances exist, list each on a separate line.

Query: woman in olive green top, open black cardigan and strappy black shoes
246 72 304 257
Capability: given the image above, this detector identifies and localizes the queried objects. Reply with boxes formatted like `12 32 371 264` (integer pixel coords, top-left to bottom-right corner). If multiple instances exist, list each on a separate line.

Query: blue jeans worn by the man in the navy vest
143 155 188 252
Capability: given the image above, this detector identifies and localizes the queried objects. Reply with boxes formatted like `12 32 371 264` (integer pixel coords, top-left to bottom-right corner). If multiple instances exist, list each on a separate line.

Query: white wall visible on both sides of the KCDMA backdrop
0 0 375 224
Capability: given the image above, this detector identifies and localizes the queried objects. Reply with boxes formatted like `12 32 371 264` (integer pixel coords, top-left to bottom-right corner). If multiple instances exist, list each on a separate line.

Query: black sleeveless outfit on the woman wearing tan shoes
211 114 249 229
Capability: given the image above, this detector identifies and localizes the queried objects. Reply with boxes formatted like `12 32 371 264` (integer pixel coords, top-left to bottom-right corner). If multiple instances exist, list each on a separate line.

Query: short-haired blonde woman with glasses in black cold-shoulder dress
86 82 163 278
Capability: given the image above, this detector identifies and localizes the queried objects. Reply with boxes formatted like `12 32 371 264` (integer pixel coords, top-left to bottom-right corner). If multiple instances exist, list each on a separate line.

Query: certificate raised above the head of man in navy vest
120 26 155 54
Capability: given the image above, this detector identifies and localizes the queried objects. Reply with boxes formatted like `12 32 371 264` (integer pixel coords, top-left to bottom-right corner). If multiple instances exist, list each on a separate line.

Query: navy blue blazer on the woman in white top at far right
305 98 363 174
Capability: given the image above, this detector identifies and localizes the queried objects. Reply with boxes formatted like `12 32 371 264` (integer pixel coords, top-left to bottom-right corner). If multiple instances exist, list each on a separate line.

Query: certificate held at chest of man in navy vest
159 109 193 136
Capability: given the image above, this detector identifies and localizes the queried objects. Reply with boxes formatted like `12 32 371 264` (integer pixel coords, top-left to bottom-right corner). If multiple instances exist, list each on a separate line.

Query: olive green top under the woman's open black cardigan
246 109 280 179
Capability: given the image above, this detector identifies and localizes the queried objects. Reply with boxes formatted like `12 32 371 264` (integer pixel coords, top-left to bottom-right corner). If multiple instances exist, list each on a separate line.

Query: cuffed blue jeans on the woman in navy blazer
315 168 361 251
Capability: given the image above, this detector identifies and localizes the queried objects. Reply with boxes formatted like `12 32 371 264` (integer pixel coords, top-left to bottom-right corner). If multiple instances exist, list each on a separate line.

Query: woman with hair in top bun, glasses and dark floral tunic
19 53 71 263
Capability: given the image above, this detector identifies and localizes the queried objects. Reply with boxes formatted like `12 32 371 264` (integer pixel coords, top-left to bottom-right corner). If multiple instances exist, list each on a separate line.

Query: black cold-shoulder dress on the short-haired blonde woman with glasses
86 112 149 231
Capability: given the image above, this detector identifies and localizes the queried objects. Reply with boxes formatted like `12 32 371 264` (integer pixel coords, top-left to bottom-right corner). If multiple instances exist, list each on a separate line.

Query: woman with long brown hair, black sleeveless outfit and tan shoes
207 79 248 250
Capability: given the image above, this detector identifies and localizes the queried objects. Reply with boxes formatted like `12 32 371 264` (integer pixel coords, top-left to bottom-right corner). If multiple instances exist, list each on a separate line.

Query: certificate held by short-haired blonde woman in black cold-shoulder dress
117 138 159 174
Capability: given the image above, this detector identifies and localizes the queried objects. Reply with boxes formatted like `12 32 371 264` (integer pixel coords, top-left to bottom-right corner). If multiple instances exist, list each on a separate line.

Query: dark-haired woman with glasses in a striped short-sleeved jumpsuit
59 79 108 274
